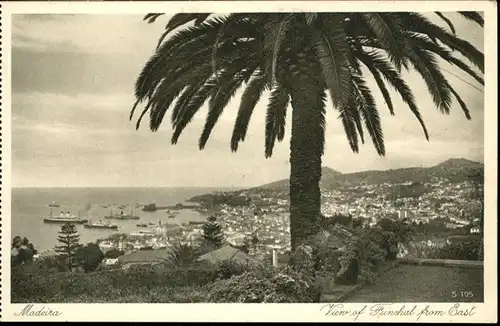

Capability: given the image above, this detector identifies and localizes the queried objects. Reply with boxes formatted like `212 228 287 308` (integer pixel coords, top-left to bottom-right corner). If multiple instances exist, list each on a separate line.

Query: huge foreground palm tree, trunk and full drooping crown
130 12 484 249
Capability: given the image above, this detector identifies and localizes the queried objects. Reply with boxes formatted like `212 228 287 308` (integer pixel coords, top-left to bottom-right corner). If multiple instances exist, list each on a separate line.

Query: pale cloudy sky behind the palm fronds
12 13 484 187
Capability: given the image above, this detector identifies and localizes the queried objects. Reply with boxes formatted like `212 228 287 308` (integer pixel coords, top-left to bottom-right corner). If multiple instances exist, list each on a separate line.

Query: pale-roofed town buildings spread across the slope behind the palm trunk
70 169 482 266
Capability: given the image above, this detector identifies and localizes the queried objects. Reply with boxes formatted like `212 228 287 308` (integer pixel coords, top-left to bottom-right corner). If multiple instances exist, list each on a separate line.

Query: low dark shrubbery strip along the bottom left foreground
11 265 217 303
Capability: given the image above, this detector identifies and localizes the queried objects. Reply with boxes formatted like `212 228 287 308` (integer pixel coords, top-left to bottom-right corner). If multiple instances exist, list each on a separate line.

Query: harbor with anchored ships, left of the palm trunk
12 188 211 252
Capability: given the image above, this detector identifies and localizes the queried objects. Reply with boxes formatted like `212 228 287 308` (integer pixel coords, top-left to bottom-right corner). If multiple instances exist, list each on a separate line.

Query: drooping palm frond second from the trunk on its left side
231 70 267 152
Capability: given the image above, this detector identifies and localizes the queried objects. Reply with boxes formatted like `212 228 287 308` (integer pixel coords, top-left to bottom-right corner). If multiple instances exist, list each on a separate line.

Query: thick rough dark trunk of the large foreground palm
290 72 325 251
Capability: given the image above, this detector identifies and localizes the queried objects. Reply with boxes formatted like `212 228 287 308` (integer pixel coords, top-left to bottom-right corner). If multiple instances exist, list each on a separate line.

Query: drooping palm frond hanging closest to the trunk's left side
265 85 290 158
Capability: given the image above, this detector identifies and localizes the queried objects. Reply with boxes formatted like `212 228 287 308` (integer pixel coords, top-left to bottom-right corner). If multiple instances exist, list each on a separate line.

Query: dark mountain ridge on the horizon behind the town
253 158 484 191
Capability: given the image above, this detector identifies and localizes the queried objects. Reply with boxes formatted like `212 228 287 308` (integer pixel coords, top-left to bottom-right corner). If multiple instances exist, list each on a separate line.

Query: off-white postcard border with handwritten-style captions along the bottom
0 1 498 323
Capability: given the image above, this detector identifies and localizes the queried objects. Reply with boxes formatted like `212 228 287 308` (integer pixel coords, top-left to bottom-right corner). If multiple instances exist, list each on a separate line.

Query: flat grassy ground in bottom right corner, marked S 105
345 265 484 302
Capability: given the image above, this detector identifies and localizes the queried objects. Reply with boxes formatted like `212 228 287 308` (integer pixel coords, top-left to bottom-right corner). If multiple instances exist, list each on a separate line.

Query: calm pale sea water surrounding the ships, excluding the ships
11 188 231 252
